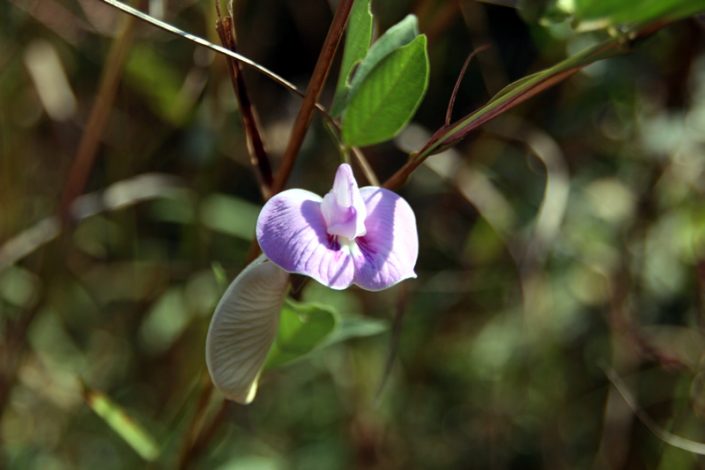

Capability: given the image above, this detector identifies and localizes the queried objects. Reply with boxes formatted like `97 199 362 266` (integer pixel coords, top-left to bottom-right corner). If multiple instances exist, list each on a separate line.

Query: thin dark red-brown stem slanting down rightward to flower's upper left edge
216 7 273 200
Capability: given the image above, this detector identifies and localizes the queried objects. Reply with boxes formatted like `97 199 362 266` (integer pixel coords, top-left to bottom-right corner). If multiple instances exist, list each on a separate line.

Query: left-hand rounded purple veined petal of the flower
257 189 355 289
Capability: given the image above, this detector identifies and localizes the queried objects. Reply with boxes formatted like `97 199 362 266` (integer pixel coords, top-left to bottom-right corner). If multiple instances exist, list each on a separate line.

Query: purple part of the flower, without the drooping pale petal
257 164 419 291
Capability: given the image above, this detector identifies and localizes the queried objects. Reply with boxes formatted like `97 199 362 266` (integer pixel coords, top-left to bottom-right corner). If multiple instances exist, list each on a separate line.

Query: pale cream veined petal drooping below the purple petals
206 256 289 404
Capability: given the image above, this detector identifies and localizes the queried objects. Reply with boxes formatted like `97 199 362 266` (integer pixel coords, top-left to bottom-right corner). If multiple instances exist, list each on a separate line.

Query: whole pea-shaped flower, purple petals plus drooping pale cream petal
206 164 419 404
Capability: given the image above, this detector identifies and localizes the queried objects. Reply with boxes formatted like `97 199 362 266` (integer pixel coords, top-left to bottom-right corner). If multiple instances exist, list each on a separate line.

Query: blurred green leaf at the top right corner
575 0 705 31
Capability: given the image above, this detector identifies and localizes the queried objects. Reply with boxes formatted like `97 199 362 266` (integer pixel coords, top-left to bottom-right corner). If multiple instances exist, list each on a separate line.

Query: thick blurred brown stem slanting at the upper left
59 11 135 225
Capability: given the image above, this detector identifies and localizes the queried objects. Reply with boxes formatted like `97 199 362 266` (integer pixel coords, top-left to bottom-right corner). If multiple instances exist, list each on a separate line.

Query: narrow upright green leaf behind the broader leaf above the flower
331 0 372 116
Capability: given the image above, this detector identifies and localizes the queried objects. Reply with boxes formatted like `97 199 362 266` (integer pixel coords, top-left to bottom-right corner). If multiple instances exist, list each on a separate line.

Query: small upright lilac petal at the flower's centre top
321 163 367 240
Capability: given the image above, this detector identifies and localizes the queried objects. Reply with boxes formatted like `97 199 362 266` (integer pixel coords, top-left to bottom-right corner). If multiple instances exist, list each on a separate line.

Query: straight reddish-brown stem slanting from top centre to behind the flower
272 0 353 194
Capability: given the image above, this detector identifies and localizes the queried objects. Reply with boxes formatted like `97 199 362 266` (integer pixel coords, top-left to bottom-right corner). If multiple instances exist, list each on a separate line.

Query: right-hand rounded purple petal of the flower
354 186 419 291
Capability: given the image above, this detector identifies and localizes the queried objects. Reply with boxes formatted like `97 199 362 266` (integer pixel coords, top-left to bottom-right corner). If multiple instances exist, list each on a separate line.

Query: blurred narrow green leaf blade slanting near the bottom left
83 385 159 462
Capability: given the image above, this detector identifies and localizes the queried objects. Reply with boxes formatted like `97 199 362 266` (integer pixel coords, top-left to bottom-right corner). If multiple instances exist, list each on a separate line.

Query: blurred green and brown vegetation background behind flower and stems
0 0 705 470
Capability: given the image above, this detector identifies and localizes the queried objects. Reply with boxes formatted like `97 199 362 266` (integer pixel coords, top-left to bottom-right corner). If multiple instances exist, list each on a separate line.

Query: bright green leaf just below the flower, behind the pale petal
265 300 337 369
